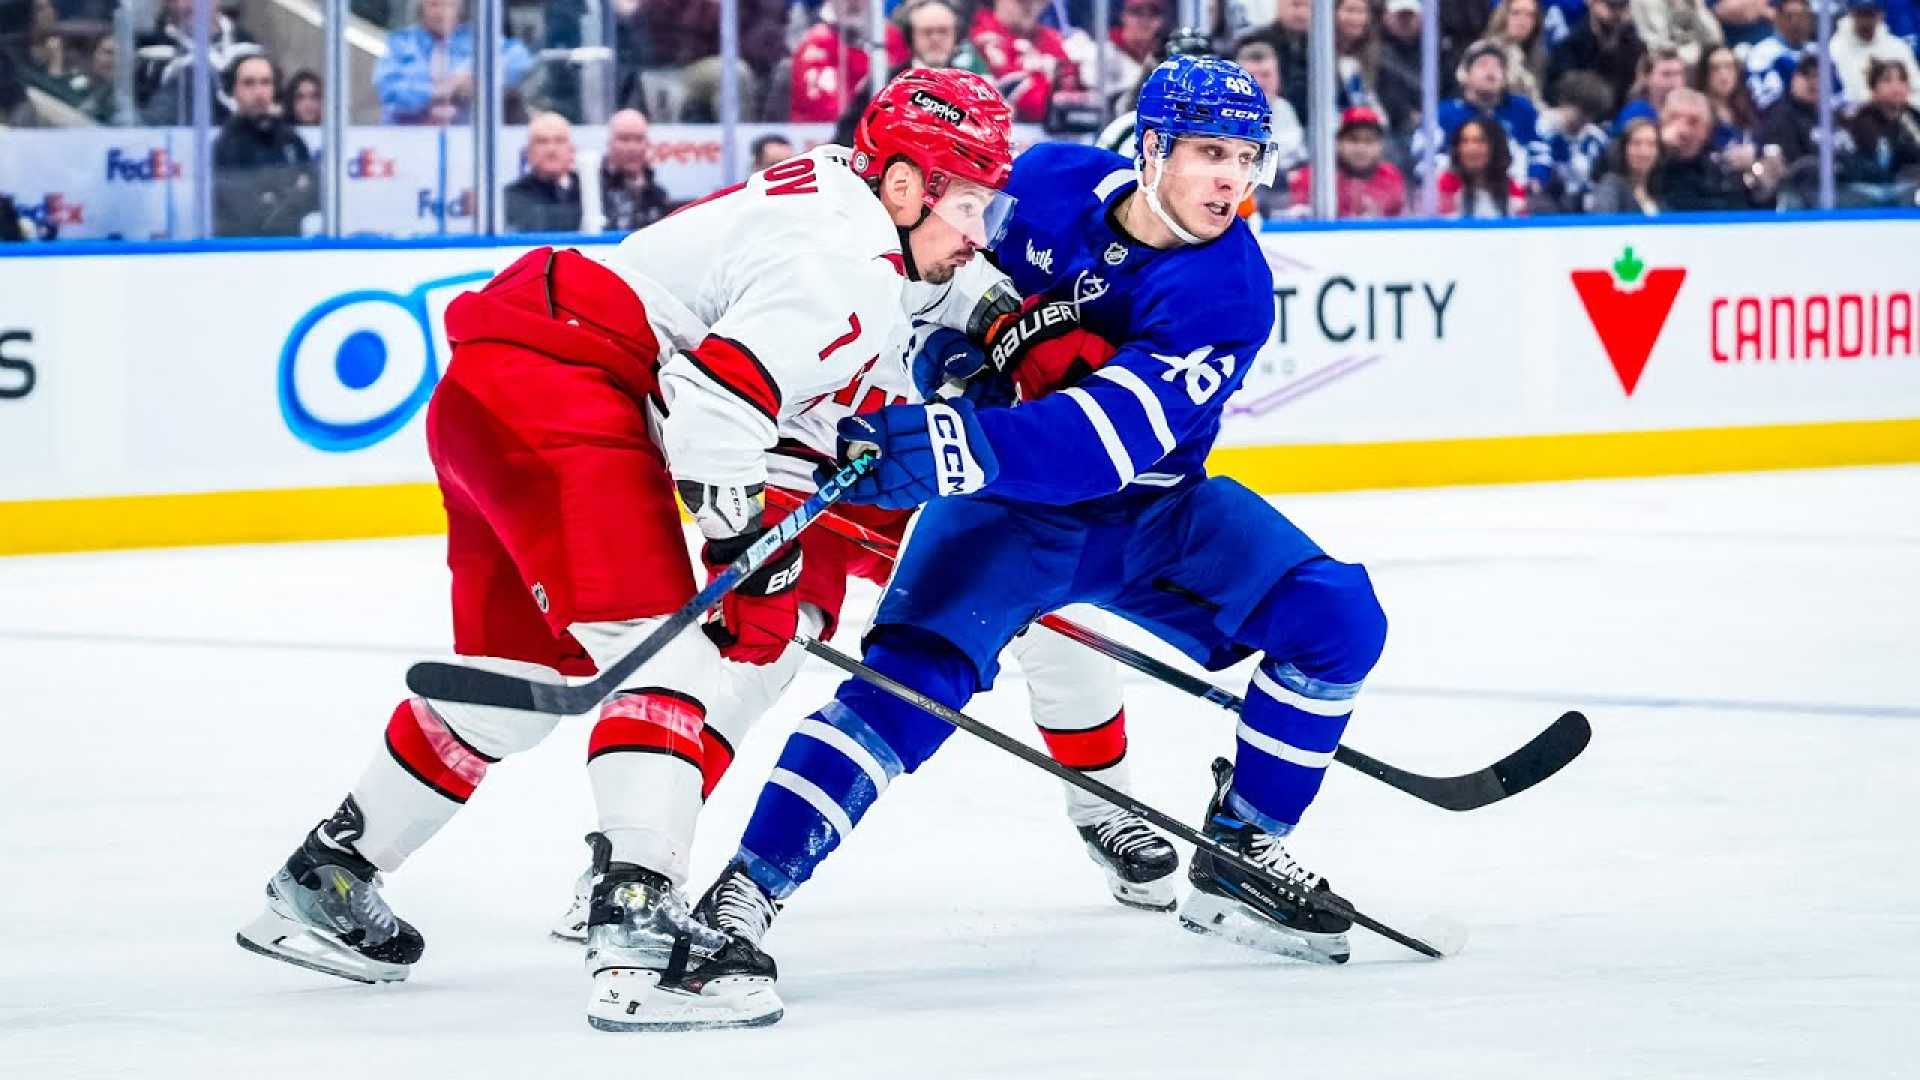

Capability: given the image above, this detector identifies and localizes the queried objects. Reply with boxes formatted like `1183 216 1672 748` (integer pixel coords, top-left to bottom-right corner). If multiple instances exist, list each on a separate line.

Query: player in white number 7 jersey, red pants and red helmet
238 71 1012 1030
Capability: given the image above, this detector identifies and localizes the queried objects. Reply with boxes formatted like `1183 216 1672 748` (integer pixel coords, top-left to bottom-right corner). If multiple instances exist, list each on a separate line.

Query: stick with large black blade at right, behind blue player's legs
772 492 1594 811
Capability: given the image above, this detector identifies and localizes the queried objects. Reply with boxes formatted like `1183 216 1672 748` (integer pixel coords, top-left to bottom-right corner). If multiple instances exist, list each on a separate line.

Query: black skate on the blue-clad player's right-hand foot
1181 757 1352 965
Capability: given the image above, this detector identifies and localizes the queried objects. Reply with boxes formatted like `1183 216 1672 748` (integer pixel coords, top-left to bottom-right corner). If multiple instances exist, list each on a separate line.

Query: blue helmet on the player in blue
1135 56 1279 184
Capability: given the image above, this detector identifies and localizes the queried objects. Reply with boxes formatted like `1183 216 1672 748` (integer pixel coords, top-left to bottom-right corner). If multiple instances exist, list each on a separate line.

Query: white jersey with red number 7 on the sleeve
595 146 912 486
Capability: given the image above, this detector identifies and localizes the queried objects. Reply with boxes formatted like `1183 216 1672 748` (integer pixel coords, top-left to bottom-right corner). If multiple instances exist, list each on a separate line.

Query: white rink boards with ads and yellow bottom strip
0 217 1920 553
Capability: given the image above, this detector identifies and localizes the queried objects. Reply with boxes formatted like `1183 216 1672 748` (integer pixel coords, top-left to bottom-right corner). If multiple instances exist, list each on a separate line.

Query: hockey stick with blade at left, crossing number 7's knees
407 454 877 717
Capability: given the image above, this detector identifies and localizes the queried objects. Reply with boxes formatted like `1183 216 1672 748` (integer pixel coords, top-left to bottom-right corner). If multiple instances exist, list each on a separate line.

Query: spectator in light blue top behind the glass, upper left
372 0 534 125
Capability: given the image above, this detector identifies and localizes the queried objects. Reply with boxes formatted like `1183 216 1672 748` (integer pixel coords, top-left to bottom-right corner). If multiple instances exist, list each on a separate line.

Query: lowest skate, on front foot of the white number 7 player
588 834 785 1032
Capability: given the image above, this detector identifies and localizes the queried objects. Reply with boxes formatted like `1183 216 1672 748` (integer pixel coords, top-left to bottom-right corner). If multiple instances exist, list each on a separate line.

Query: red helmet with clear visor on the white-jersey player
852 67 1014 248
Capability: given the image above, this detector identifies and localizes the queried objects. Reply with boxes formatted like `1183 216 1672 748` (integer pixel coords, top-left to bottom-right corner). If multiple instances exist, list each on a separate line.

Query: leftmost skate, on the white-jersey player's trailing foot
234 796 426 984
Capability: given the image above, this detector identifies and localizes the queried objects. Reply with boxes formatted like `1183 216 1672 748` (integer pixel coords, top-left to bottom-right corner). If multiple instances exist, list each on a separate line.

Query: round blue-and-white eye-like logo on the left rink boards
275 271 493 454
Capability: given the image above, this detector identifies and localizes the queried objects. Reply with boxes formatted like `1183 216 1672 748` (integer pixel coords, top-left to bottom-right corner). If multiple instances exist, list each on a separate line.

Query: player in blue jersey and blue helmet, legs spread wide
701 58 1386 963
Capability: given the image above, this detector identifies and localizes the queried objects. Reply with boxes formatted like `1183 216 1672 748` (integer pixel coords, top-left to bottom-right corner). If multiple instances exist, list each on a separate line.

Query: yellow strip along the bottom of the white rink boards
0 419 1920 555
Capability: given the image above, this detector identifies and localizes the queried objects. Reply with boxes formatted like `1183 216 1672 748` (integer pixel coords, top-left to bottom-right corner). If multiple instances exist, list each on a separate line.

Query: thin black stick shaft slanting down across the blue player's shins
793 636 1448 959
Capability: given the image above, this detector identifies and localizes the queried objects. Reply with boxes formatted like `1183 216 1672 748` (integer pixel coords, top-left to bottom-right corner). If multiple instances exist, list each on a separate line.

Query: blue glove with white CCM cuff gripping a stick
839 400 1000 509
